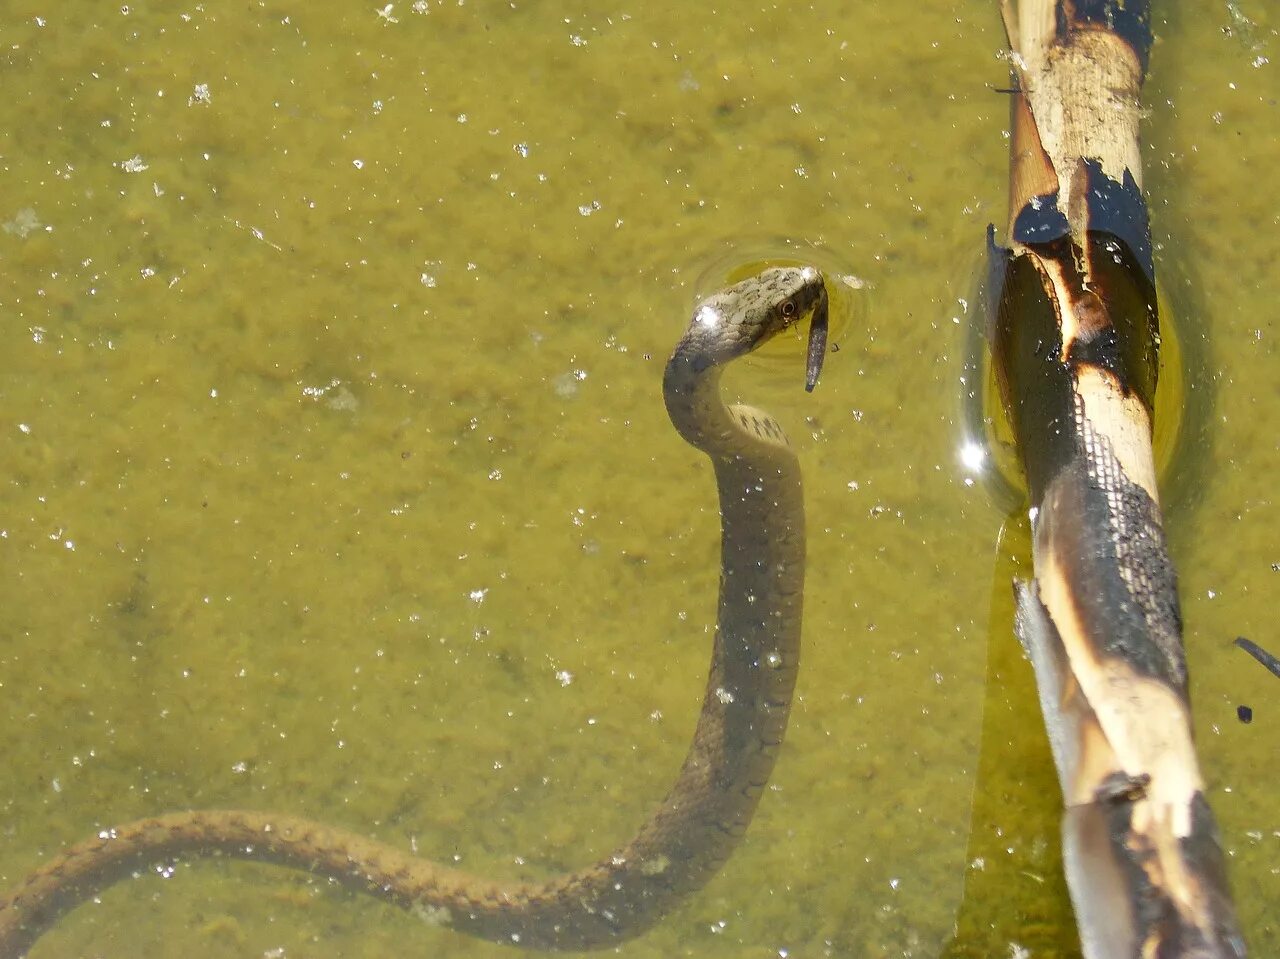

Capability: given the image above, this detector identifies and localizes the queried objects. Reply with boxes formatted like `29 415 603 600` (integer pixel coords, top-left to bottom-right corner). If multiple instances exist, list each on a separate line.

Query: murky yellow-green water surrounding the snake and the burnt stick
0 0 1280 959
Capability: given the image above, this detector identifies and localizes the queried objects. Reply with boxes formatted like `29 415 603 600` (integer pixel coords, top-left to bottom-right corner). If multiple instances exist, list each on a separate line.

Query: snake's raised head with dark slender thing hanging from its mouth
689 266 828 391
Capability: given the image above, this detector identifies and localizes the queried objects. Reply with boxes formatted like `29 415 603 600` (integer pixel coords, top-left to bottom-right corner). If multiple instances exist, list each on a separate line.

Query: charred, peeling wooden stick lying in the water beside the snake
991 0 1245 959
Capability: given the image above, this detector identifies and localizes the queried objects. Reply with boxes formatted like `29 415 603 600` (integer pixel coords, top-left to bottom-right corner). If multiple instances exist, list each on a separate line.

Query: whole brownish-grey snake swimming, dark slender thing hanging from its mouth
0 266 828 959
